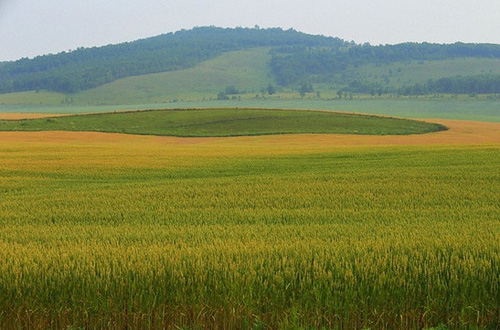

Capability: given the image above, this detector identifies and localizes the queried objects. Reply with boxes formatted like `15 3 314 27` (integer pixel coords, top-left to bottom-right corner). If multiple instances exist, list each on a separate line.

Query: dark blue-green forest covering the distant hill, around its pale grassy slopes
0 27 500 95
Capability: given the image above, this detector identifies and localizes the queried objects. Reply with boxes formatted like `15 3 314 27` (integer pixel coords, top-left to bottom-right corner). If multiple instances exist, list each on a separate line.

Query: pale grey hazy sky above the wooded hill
0 0 500 61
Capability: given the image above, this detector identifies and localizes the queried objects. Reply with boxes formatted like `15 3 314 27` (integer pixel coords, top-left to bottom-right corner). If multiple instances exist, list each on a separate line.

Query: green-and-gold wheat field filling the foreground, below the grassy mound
0 120 500 330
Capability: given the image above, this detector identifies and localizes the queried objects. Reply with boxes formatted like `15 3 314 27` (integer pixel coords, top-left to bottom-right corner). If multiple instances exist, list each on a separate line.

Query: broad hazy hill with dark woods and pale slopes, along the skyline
0 27 500 105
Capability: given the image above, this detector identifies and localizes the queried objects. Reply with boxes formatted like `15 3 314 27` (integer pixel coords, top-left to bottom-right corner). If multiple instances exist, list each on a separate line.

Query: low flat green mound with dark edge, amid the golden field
0 109 446 136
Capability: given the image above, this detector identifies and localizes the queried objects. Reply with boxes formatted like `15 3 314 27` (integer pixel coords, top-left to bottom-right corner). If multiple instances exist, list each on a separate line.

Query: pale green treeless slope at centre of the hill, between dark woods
73 48 273 105
